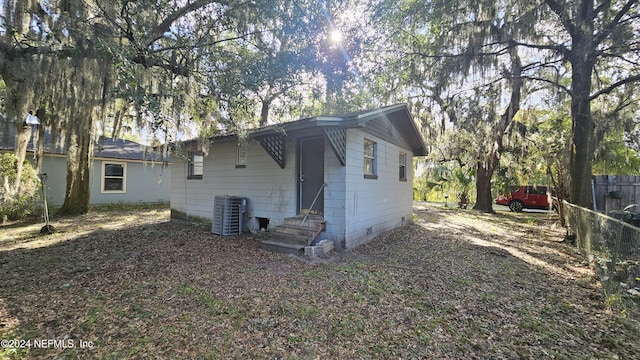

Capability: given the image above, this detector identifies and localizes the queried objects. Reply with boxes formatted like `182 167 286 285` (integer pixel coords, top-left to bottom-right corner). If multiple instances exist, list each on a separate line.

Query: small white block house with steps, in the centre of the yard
171 104 426 252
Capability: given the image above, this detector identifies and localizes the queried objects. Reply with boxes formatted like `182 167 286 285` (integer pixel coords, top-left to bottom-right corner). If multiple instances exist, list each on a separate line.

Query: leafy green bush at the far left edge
0 153 40 220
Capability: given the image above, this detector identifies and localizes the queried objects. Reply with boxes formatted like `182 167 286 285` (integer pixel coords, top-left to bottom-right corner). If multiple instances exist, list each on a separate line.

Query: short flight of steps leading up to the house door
260 215 326 255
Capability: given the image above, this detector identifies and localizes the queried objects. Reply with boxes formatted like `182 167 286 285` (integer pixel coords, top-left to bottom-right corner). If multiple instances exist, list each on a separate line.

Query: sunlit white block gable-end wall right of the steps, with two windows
338 129 413 248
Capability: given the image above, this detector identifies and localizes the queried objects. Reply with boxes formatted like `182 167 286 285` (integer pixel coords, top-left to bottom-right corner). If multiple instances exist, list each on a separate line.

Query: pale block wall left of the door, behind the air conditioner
171 138 297 230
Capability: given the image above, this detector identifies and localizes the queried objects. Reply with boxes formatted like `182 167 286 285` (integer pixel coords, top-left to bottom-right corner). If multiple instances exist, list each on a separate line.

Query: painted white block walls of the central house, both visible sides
171 129 413 249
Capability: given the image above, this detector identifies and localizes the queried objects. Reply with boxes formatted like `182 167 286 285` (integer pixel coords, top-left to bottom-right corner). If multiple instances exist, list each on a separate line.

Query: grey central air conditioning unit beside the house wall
211 196 247 236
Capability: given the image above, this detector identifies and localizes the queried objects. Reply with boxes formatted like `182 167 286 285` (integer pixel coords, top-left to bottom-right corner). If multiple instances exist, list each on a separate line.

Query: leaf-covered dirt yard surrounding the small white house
0 206 640 359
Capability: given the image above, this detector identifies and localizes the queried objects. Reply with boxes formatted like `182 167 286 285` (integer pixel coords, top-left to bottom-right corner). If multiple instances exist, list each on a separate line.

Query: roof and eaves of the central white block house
183 104 427 156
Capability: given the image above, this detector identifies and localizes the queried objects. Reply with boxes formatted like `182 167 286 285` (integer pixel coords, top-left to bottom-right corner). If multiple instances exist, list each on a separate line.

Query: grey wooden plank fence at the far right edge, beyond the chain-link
594 175 640 214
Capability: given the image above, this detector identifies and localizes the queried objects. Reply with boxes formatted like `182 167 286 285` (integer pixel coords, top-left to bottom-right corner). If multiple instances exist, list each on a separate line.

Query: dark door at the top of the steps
298 137 324 214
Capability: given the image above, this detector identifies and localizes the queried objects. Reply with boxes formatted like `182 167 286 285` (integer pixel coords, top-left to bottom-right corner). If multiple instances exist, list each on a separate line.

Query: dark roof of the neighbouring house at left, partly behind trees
0 126 171 162
